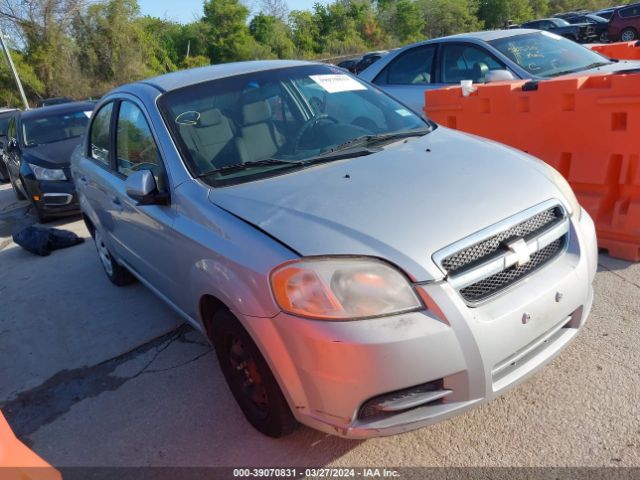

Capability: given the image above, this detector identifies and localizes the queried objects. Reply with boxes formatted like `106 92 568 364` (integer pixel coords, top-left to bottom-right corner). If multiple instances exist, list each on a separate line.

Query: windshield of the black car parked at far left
22 111 91 147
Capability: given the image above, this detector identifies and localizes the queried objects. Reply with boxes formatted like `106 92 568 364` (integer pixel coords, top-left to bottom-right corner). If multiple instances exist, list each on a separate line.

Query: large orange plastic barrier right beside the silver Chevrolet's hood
425 75 640 261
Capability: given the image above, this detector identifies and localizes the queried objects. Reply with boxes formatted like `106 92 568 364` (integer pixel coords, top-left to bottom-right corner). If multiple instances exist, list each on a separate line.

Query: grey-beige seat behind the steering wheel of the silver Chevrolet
236 100 284 162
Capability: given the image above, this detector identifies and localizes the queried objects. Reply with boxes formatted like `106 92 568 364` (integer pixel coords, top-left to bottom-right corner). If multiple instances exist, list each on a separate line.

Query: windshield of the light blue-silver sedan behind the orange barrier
489 32 611 77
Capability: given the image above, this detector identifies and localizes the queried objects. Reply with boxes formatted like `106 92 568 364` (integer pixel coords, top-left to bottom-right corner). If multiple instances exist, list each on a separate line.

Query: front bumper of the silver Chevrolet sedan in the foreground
245 212 597 438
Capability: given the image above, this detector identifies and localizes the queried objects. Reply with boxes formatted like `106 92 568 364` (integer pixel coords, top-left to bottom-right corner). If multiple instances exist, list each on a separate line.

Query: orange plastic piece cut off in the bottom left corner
0 412 62 480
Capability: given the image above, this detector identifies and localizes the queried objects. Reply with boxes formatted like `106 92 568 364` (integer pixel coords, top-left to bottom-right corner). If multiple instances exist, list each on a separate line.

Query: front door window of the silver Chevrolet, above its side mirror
116 100 162 185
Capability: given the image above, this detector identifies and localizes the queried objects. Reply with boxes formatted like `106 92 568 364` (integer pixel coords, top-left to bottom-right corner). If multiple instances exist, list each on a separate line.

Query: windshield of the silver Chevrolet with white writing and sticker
158 65 430 186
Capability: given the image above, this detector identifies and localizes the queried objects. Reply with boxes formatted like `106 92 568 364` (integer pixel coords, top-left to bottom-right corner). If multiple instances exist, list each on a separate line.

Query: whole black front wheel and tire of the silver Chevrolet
211 309 298 438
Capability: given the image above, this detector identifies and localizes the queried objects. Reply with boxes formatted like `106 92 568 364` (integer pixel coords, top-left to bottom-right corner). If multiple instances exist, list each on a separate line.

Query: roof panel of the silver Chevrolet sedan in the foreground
127 60 313 91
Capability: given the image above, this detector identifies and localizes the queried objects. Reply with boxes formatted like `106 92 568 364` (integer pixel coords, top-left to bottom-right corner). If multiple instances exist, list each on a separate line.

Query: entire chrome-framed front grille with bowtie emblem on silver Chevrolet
433 199 570 306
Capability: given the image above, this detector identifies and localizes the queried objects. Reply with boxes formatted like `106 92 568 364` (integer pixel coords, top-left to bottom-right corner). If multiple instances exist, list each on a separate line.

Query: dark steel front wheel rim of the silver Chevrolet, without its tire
227 336 269 418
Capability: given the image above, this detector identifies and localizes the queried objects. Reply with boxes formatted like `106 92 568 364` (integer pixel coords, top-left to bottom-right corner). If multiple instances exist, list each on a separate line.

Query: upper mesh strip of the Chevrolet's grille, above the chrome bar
442 207 563 275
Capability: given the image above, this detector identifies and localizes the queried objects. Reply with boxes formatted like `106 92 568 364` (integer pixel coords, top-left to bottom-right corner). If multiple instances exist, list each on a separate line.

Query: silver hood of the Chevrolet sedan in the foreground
209 127 560 281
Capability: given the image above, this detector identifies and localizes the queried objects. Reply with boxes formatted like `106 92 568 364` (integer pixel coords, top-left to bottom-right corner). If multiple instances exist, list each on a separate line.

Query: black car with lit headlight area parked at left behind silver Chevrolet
5 102 94 222
